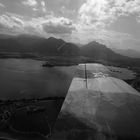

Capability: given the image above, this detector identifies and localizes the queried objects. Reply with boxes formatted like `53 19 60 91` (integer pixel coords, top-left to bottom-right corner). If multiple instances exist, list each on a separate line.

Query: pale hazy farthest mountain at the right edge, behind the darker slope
112 48 140 58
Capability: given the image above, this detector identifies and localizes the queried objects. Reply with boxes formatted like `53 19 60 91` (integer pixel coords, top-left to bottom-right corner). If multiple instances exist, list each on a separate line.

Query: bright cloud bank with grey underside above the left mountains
0 13 75 37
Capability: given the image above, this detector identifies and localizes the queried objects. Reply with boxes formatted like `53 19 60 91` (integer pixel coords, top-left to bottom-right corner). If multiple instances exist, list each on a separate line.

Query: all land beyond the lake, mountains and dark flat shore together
0 35 140 90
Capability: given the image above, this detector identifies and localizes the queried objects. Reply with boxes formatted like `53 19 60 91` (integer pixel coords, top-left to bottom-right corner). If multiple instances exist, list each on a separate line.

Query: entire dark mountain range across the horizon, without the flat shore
0 35 140 64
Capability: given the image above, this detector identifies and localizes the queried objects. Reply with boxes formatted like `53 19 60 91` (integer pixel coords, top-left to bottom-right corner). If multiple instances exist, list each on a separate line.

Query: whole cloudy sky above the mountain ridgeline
0 0 140 51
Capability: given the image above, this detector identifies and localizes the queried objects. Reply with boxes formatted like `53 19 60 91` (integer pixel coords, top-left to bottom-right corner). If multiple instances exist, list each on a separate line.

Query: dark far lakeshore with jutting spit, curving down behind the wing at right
0 55 140 91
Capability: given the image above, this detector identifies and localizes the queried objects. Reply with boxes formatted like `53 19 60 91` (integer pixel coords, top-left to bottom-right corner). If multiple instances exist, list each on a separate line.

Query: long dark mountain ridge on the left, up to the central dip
0 35 79 56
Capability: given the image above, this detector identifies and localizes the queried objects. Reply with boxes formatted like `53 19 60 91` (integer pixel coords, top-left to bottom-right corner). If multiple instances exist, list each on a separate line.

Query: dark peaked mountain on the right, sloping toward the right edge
80 41 140 66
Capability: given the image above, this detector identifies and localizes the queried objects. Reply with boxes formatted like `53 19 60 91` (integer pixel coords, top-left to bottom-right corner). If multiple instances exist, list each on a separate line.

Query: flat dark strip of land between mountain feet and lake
0 52 140 68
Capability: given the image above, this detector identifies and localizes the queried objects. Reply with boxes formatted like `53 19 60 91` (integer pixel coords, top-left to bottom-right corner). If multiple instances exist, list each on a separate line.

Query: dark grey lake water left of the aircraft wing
0 59 76 99
